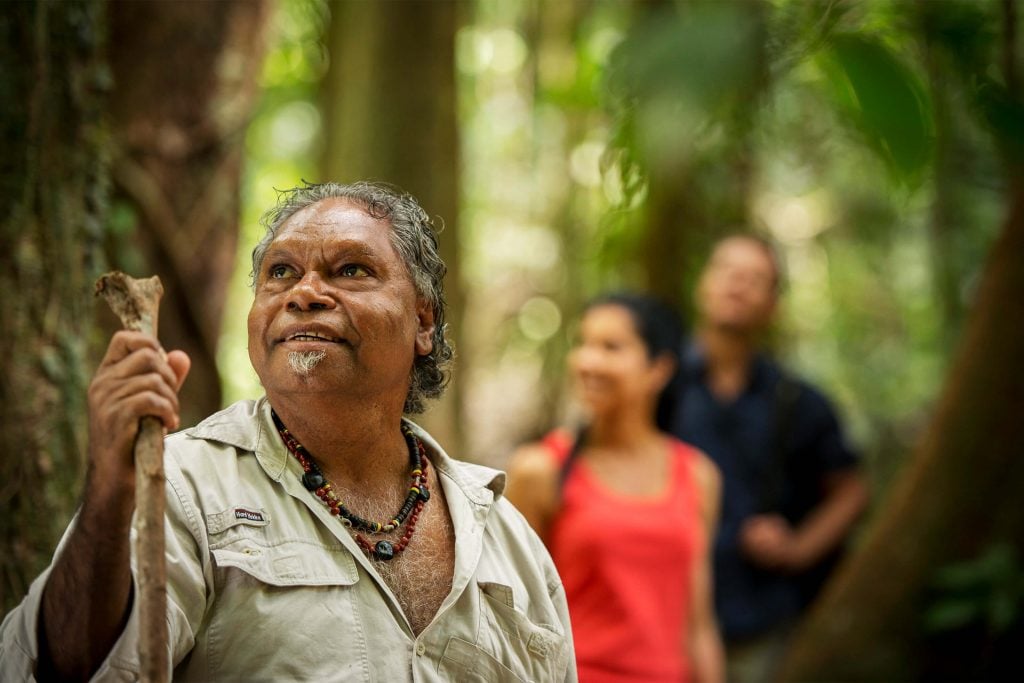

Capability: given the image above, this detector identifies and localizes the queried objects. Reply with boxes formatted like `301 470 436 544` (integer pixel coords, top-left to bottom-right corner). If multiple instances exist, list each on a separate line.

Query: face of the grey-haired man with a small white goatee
249 199 434 404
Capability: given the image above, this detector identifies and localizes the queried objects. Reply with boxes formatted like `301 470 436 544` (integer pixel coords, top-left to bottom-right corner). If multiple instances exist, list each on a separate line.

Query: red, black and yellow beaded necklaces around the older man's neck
270 410 430 560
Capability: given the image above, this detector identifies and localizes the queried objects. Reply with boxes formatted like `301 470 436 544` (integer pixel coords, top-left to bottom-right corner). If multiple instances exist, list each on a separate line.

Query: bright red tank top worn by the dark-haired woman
544 431 707 683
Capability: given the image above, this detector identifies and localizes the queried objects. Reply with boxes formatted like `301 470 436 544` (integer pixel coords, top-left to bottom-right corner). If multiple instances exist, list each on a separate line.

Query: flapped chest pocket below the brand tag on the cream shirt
201 532 369 681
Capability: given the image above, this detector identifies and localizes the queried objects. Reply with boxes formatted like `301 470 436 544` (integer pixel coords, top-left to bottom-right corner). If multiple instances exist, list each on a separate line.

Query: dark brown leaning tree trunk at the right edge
779 175 1024 681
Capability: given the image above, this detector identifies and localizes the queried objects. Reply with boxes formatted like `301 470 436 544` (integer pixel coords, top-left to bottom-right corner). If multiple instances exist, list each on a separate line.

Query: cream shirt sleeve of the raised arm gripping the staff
0 459 206 682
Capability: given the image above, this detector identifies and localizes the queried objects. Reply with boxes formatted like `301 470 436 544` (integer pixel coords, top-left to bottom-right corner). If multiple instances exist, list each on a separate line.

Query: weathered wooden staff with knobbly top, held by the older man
96 271 168 683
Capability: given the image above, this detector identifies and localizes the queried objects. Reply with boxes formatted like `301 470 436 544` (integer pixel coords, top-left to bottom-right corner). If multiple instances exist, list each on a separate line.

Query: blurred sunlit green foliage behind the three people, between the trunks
221 0 1007 490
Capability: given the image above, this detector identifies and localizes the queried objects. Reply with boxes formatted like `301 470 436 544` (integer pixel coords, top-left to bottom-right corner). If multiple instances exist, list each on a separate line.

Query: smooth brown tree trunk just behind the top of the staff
109 0 270 425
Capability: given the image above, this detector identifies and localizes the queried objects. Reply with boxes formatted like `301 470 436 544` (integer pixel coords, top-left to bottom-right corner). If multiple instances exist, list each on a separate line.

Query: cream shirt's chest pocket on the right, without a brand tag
441 582 569 682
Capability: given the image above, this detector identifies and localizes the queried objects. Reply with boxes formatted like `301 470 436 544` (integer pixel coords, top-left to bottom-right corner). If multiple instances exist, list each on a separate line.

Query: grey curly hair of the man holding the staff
250 181 454 415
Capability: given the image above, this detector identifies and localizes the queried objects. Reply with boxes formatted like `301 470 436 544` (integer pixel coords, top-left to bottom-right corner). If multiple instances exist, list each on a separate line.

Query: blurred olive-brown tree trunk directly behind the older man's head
321 0 465 457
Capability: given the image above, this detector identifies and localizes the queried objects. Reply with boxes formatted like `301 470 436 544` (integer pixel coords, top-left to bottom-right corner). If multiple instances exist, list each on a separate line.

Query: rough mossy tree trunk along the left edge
0 0 109 611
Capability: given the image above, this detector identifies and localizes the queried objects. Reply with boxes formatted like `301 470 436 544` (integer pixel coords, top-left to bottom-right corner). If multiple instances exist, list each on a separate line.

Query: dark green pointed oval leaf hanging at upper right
824 34 932 178
